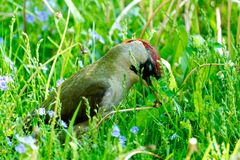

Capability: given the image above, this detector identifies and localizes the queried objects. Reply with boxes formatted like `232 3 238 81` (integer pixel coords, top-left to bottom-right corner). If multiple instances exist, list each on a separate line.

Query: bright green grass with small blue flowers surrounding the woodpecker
0 0 240 159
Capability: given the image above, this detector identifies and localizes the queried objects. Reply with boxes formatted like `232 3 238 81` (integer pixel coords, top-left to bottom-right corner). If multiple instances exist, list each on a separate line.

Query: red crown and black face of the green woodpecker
124 39 161 83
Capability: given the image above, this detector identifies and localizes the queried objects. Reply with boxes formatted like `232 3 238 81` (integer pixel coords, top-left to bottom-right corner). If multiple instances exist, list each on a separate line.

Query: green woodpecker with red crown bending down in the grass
41 39 161 128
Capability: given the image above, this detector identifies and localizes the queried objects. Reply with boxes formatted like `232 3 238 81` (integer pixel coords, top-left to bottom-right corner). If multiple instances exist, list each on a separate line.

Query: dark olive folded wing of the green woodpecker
60 80 110 123
